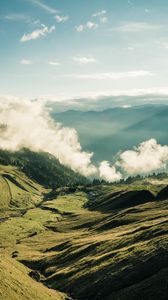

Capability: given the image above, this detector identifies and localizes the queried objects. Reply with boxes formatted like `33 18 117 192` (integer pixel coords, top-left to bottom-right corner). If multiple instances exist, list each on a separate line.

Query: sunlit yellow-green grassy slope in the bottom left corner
0 255 67 300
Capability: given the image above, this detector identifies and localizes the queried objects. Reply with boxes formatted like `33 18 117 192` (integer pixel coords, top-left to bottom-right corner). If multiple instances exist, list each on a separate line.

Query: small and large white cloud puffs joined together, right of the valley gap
99 139 168 182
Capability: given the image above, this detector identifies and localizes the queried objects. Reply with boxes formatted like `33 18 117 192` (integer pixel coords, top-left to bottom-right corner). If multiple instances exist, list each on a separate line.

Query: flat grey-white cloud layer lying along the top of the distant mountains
45 94 168 112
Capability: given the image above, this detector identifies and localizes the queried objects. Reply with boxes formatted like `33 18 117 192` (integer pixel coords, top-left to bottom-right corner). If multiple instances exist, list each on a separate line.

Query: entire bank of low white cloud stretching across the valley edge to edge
0 97 168 182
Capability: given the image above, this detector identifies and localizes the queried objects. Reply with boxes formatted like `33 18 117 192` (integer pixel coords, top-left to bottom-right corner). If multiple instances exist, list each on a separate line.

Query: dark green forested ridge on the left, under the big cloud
0 148 87 188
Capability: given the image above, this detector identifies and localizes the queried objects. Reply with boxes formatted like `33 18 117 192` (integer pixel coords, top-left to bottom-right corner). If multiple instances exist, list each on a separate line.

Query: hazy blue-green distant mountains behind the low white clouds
52 105 168 161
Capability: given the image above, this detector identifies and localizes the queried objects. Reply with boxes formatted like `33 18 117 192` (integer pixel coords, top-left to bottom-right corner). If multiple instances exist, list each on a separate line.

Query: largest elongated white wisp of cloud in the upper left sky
20 25 55 43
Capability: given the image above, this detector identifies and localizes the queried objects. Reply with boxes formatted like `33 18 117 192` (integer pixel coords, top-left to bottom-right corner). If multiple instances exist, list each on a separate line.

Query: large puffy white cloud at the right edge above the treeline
116 139 168 175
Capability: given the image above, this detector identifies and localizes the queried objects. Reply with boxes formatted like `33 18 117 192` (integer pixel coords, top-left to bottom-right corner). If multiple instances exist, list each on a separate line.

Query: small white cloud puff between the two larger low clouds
99 161 122 182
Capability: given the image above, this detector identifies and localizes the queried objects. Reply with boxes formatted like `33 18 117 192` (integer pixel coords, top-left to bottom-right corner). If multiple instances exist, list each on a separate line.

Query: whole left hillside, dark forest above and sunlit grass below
0 149 87 210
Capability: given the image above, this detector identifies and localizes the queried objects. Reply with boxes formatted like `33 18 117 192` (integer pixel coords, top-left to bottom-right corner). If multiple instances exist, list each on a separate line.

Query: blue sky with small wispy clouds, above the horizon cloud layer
0 0 168 99
